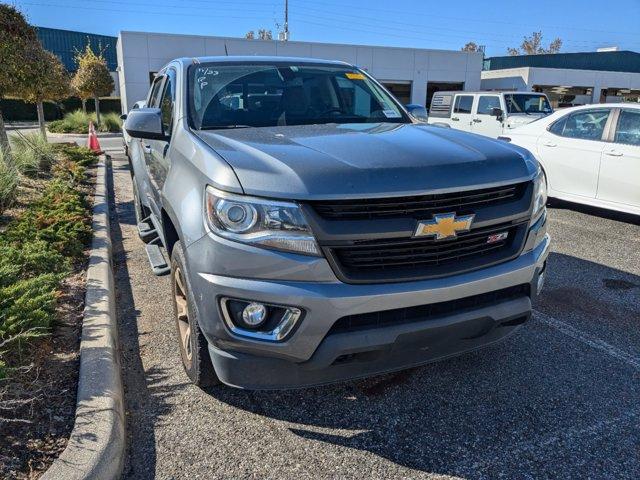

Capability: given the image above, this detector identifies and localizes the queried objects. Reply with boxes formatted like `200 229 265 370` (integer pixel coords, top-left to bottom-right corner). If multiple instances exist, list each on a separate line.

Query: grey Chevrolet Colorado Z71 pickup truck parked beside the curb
125 57 549 389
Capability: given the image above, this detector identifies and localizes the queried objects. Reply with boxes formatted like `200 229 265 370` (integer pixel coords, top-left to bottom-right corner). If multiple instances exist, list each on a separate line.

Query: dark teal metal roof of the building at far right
483 50 640 73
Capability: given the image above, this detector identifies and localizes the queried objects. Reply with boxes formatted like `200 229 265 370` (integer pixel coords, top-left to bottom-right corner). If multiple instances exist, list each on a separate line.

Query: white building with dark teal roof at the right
481 49 640 107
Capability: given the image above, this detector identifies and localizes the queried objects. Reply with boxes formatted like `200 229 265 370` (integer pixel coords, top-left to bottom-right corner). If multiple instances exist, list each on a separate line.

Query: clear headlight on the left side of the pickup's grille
205 186 322 256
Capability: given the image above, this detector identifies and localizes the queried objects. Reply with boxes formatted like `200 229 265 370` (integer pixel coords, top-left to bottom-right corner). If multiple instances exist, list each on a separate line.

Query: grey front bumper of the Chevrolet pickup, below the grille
187 219 549 389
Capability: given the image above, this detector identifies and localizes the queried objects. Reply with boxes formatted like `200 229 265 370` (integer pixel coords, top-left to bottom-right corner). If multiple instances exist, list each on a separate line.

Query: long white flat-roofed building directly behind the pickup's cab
117 32 482 112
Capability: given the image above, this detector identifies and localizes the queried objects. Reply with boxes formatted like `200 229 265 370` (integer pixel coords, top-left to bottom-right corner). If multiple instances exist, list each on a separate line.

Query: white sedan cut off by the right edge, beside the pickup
498 103 640 215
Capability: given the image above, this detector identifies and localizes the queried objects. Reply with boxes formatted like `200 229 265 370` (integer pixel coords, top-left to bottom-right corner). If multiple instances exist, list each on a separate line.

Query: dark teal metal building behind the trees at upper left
36 27 118 72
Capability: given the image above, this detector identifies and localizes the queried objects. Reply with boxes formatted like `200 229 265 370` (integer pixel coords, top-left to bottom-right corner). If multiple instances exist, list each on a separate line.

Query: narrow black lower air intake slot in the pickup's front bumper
328 284 529 335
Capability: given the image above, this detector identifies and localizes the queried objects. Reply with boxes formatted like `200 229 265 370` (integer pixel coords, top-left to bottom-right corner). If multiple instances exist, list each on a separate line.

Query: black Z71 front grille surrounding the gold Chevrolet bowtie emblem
304 181 533 283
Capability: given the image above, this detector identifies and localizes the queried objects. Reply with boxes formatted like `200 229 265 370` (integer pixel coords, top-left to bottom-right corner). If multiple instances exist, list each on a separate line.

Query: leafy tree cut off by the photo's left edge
0 3 39 158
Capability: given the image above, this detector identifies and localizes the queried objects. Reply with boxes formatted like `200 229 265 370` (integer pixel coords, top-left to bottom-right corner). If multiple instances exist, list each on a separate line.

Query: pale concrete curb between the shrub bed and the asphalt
41 156 125 480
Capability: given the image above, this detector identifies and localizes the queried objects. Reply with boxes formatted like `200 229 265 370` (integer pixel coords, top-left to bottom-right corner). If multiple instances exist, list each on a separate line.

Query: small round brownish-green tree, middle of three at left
18 47 71 139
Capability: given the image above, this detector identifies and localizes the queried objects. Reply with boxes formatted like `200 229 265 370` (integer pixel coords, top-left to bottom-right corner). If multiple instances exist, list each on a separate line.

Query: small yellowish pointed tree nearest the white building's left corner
71 43 114 126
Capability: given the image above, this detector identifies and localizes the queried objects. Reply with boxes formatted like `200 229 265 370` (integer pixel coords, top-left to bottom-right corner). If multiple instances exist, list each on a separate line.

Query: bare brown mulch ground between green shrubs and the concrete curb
0 160 96 479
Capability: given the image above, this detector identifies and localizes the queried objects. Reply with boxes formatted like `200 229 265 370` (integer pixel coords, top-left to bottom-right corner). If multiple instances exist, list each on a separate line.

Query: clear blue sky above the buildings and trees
8 0 640 55
